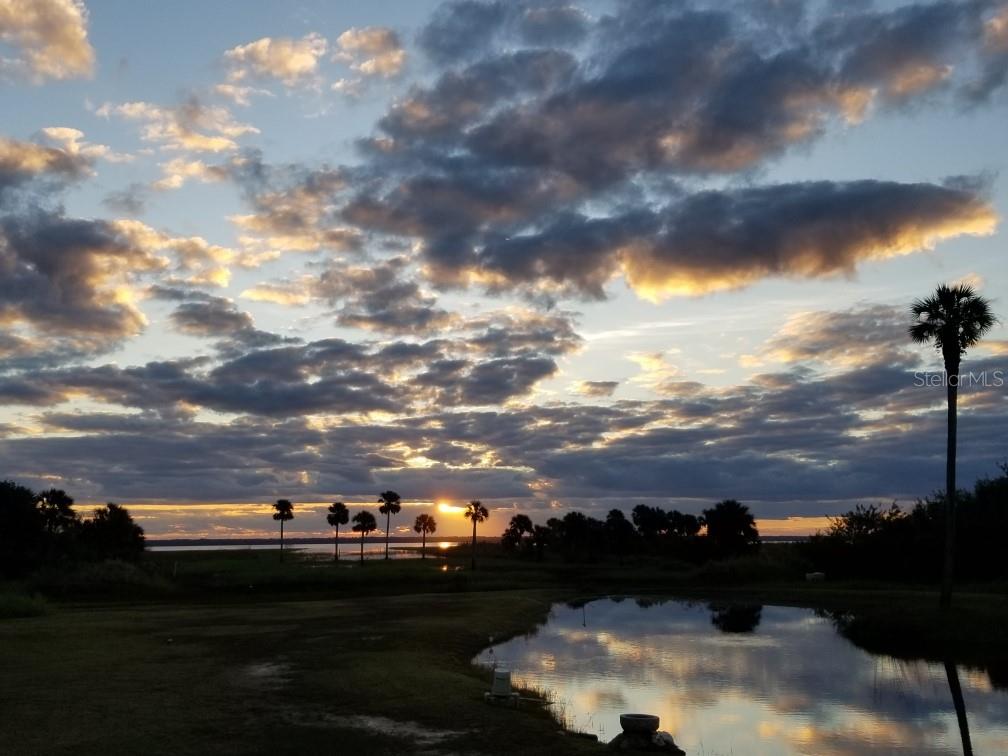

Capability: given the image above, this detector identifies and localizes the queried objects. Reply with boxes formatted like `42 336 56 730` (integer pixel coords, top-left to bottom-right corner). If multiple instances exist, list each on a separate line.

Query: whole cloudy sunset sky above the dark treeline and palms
0 0 1008 537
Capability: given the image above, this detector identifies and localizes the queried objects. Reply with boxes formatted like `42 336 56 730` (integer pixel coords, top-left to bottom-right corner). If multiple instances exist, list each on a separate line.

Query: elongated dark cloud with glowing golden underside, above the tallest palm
622 180 997 297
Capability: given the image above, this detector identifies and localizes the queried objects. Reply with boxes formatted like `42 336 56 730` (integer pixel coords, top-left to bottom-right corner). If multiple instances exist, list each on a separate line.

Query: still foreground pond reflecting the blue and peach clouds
477 599 1008 756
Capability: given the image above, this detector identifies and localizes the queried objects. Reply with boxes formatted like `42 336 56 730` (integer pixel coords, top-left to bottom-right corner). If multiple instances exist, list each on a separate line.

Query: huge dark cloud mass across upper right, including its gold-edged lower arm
340 2 1008 297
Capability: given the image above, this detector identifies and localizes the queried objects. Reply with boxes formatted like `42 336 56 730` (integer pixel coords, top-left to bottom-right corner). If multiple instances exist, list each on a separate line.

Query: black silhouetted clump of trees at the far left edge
0 481 144 575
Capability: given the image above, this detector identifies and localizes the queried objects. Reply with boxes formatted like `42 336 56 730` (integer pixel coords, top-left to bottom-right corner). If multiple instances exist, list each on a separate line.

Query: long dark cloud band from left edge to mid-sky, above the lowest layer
0 304 580 417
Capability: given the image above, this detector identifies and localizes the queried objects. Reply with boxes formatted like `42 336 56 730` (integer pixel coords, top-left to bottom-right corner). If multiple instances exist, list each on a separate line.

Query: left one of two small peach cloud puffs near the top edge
224 33 329 87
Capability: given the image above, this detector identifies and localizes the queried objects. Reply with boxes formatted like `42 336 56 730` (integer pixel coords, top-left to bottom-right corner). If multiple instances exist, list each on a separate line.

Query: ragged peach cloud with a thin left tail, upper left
95 97 259 152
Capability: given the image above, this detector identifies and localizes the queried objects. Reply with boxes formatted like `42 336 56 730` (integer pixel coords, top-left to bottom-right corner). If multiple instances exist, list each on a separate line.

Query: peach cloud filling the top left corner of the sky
0 0 95 83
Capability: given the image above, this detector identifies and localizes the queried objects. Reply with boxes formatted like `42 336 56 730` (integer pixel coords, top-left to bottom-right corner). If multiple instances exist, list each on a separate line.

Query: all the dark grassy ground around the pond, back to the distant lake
0 551 1008 754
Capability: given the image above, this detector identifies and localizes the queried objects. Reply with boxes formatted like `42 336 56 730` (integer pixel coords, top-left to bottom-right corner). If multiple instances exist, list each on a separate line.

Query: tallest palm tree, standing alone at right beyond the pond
909 283 994 609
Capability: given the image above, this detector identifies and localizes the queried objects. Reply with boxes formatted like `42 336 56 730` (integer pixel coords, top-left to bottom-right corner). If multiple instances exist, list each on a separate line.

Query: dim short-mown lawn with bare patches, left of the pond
0 576 593 755
